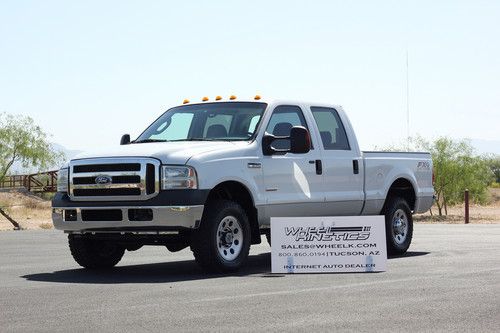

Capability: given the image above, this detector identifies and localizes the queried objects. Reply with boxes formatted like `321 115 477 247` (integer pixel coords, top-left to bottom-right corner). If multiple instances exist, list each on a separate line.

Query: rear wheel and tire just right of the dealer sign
385 197 413 255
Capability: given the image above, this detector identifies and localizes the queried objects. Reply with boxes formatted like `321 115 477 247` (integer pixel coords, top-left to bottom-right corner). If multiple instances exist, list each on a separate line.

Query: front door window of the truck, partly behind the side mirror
266 105 307 149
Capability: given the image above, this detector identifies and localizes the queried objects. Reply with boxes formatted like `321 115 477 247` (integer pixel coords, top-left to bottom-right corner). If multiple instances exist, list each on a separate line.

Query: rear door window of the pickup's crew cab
311 106 351 150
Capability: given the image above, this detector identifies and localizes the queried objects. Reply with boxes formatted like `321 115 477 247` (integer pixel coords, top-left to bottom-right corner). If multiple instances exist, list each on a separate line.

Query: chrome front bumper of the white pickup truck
52 205 204 231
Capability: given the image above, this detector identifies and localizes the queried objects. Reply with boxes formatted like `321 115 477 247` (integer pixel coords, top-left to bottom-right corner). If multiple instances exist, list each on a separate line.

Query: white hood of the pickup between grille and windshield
73 141 244 164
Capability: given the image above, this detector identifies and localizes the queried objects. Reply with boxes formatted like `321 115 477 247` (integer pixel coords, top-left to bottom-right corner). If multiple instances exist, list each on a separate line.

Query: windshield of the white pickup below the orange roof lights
133 102 267 143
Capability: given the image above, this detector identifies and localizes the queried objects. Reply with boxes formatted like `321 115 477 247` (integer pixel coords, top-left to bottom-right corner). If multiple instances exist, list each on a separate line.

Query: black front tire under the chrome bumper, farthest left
68 235 125 269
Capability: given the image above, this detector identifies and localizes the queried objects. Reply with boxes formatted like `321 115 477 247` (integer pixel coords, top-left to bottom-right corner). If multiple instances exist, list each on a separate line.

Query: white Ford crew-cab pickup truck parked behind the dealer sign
52 96 434 272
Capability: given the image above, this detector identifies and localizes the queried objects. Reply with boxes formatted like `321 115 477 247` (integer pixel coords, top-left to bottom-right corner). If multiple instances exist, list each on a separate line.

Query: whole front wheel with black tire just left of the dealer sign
191 200 251 272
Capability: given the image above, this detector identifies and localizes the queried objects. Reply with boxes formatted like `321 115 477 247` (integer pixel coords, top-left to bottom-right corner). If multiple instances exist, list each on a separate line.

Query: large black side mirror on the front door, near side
262 126 311 156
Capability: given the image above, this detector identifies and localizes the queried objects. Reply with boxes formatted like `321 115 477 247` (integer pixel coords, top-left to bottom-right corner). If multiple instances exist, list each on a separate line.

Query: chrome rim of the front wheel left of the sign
215 216 243 261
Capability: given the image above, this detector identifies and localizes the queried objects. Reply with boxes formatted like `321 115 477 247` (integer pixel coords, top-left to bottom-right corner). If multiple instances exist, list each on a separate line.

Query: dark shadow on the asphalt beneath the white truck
21 251 429 284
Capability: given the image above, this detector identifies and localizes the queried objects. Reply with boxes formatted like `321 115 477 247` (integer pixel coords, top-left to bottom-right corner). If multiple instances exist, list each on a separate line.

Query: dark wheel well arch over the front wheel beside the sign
203 181 261 244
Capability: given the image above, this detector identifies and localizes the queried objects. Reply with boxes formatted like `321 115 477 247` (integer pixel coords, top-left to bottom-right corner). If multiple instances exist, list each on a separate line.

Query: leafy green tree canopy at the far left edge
0 113 63 181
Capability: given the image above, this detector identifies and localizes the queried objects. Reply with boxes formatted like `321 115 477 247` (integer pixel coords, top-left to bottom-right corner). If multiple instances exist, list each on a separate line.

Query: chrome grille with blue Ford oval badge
69 158 160 201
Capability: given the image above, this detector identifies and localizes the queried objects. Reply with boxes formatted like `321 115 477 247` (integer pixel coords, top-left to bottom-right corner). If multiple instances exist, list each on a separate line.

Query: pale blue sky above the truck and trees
0 0 500 150
